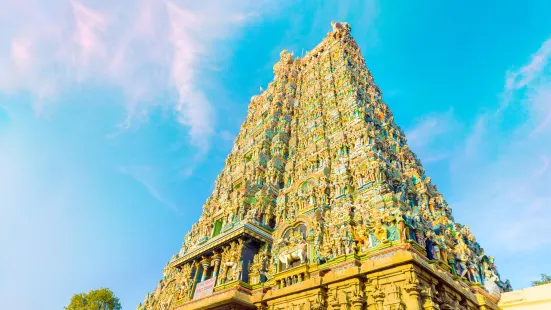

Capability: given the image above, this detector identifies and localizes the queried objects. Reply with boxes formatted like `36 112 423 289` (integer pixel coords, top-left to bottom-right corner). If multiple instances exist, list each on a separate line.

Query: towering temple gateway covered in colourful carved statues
138 23 511 310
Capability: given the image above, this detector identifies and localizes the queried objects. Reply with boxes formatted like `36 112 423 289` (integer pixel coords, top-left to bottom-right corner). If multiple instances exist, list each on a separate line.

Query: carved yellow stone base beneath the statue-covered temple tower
173 244 499 310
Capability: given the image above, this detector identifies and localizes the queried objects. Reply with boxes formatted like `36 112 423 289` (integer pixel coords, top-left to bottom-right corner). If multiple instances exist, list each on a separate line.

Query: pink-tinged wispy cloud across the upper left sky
0 0 268 152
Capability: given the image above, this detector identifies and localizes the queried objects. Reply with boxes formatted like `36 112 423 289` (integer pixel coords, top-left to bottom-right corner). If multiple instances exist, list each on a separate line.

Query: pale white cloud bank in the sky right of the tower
407 38 551 287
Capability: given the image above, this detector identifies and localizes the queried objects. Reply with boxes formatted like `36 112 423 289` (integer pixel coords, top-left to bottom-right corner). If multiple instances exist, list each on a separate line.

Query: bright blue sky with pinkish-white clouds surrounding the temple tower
0 0 551 310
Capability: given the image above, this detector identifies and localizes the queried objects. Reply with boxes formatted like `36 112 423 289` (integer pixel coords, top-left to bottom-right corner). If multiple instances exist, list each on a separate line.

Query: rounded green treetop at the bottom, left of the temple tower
65 288 122 310
